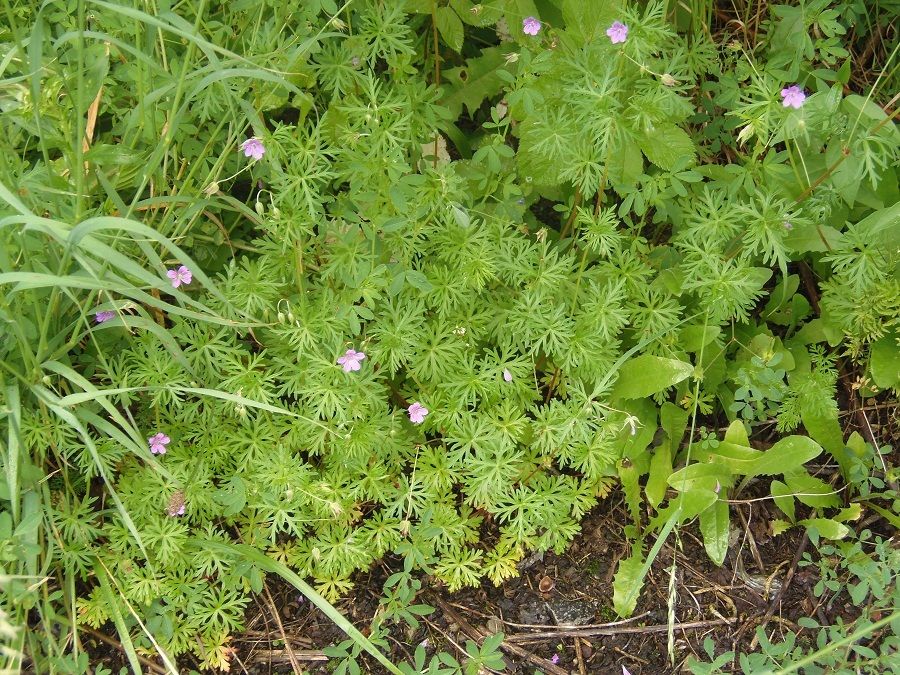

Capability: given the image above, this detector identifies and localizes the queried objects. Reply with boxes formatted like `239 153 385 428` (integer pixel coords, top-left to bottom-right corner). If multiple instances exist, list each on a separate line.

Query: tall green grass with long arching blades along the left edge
0 0 399 673
